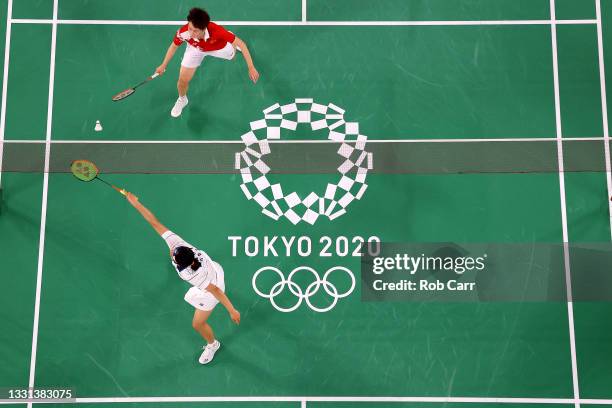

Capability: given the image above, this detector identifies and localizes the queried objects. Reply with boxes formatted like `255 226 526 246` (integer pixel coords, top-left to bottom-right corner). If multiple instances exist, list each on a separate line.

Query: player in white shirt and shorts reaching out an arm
126 193 240 364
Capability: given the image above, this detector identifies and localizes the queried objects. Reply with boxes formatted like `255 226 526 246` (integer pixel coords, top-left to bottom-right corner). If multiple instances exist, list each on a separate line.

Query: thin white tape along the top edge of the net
0 136 604 144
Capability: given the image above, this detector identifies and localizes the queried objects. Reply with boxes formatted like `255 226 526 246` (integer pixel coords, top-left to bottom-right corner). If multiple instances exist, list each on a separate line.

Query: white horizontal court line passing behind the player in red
11 18 597 26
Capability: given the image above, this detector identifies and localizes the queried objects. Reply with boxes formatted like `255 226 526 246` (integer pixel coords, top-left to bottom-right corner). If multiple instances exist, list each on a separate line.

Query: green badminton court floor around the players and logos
0 0 612 408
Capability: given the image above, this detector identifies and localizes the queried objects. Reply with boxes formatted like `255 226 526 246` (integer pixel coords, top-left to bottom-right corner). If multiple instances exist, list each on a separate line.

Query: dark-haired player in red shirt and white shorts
155 8 259 118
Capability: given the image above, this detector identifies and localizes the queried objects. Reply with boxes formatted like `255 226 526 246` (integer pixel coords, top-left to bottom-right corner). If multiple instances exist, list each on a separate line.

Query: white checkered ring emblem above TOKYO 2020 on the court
235 98 373 225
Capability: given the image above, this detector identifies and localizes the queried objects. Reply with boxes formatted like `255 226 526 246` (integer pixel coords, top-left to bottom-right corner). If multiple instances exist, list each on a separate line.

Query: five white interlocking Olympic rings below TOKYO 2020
252 266 355 313
